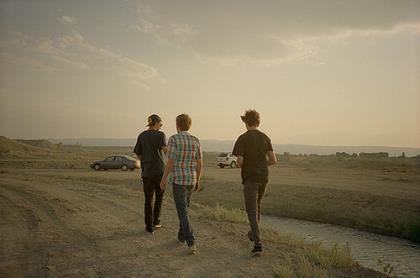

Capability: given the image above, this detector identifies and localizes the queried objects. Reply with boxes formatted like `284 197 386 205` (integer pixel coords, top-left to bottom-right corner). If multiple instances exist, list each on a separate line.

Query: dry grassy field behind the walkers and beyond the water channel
0 138 420 242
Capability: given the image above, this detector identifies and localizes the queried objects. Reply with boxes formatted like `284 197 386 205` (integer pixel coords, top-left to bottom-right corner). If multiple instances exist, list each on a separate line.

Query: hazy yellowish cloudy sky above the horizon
0 0 420 147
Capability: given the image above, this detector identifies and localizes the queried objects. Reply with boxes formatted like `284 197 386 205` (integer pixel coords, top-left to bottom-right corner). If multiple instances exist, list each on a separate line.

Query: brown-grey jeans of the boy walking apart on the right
244 181 267 246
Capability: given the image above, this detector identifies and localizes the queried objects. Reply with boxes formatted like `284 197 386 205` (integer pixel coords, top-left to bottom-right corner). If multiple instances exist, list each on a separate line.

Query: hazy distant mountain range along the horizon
48 138 420 156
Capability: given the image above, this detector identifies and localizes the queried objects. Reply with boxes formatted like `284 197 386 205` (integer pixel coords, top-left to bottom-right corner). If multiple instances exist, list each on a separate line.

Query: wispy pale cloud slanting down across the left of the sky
0 30 161 88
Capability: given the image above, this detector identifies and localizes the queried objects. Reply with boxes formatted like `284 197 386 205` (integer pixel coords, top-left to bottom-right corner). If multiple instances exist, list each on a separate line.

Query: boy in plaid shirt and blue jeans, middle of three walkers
160 114 203 254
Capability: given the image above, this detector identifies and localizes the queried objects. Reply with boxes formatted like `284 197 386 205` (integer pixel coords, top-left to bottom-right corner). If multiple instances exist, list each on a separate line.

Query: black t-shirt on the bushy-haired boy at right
232 129 273 183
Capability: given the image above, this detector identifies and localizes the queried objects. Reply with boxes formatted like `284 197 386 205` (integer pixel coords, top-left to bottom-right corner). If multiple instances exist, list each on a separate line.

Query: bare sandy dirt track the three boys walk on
0 169 384 277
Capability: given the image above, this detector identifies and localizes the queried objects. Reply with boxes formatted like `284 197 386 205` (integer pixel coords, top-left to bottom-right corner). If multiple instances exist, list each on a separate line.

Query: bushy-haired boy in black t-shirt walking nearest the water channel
232 110 277 256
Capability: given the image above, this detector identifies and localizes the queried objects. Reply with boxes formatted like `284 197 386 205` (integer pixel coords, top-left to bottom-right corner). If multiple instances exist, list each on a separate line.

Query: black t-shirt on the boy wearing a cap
133 129 166 177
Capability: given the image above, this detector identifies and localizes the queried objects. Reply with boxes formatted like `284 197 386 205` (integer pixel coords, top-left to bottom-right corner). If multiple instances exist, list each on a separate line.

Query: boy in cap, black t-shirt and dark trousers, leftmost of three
134 114 168 234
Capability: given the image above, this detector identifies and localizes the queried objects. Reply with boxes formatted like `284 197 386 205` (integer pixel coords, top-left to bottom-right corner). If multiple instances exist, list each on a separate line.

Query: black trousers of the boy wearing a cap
143 176 165 229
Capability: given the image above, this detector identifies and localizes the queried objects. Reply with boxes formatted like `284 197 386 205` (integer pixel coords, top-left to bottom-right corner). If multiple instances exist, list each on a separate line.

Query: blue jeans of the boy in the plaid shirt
172 183 194 246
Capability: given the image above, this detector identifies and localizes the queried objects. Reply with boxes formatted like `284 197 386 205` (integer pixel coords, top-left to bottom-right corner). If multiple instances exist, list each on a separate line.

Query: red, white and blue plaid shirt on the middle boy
168 131 202 185
